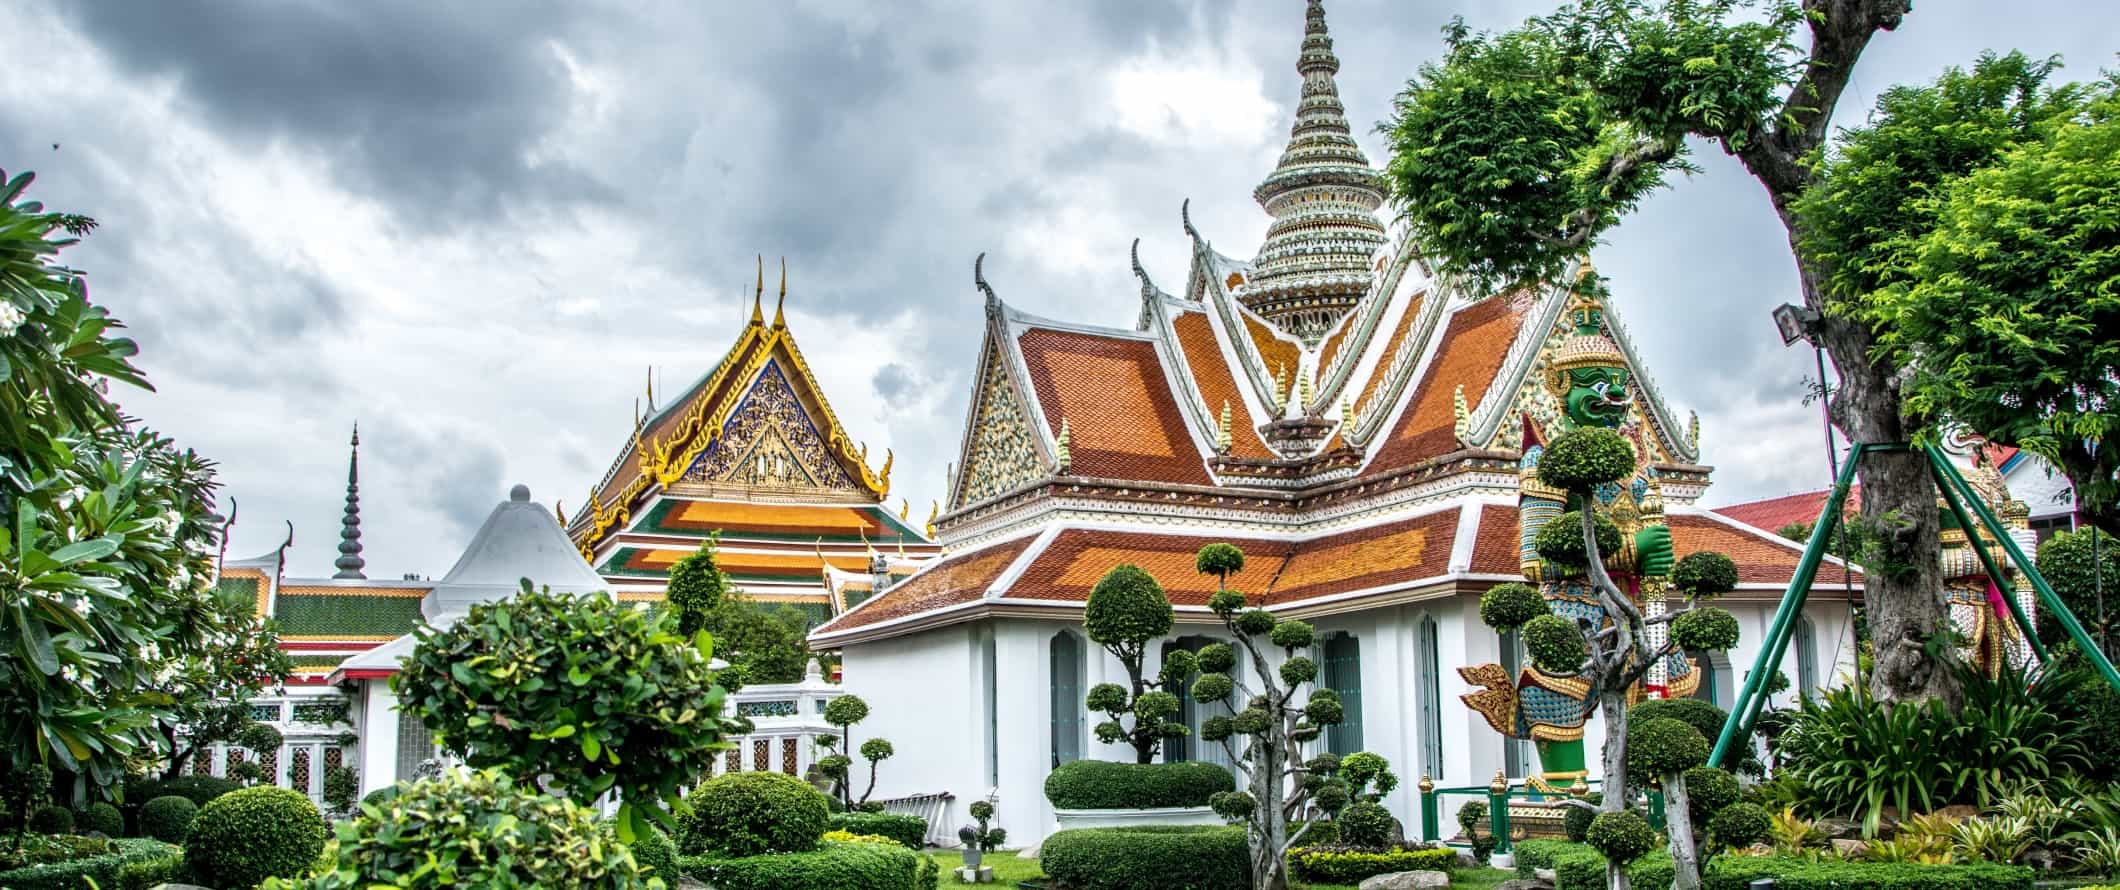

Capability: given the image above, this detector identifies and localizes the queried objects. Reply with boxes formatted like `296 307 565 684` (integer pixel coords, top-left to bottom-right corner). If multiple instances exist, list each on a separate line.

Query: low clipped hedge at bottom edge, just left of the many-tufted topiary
1039 824 1251 890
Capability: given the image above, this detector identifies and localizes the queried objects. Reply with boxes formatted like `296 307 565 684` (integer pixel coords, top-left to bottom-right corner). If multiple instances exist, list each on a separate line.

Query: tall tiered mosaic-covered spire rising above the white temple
1236 0 1384 341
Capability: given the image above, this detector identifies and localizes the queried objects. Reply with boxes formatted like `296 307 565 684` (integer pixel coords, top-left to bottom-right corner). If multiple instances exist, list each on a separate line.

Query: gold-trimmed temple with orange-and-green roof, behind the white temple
566 265 939 623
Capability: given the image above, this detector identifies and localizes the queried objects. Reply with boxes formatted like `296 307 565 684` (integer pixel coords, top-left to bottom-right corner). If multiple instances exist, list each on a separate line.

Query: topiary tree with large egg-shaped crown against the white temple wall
1081 564 1196 763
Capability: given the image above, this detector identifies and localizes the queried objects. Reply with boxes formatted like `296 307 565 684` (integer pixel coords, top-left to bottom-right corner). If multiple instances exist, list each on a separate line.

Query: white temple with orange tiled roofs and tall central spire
812 0 1859 843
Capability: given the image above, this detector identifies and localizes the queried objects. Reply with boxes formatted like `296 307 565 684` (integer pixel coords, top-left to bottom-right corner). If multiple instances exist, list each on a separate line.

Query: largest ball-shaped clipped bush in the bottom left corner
184 786 329 888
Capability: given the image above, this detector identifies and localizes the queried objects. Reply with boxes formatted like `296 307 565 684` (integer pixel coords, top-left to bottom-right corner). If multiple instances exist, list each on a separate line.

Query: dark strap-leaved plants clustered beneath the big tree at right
1777 668 2109 835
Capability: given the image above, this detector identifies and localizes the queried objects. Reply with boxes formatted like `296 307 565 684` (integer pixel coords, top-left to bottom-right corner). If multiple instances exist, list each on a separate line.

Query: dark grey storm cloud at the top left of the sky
57 0 608 214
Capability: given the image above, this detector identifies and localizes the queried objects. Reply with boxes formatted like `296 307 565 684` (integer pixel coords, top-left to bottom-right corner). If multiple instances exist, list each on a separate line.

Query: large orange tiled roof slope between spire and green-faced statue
1370 297 1524 475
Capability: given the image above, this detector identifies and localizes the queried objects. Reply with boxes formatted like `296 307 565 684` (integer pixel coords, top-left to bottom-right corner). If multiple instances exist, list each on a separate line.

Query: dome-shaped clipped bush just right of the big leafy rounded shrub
678 771 831 858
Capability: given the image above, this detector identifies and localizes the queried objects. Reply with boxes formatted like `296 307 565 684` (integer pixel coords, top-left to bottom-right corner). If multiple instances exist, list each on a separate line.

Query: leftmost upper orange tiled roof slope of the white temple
1018 328 1221 485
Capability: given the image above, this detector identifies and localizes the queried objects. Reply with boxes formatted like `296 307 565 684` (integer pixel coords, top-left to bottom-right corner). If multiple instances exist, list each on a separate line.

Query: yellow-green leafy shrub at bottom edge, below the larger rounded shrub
273 769 668 890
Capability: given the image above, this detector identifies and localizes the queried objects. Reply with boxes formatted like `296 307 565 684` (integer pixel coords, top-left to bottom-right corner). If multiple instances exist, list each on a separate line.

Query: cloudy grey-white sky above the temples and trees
0 0 2120 579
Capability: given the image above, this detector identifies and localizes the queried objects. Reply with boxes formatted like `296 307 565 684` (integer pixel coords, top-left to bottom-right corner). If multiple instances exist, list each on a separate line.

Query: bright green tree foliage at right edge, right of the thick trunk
1794 53 2120 528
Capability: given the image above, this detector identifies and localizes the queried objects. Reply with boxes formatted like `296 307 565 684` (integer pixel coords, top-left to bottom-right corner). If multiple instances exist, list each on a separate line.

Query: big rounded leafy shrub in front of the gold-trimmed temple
390 579 736 839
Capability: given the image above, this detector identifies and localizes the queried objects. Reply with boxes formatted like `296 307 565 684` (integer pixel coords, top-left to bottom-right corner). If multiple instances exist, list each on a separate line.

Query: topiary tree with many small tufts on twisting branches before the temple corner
1191 545 1348 890
